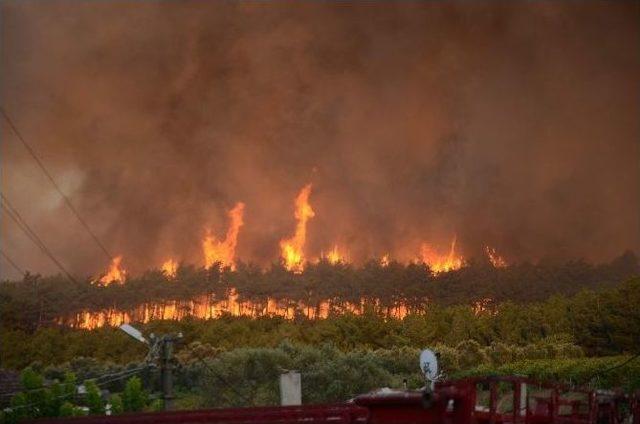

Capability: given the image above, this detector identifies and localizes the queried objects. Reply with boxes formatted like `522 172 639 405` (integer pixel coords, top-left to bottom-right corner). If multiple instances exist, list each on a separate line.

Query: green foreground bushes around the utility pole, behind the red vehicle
5 338 640 421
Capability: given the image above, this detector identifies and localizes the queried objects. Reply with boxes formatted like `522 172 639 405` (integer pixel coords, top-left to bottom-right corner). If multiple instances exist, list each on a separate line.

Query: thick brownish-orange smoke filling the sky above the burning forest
0 1 640 277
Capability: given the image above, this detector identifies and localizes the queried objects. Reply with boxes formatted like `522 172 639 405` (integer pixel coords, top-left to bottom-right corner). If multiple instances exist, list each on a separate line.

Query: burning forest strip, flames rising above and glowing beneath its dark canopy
1 179 640 329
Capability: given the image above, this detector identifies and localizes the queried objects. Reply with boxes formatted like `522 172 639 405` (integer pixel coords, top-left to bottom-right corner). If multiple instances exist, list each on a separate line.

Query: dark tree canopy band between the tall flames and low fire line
0 252 640 332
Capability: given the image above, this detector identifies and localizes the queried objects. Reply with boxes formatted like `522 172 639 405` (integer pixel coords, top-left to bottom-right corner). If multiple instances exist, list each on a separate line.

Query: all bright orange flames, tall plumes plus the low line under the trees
59 184 507 329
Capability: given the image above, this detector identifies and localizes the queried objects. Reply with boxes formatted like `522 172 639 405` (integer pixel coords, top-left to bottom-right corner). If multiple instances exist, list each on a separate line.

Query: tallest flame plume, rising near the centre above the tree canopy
280 184 315 273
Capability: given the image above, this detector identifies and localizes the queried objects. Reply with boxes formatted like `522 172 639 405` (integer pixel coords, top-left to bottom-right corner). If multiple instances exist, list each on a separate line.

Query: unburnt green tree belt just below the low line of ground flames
0 278 640 369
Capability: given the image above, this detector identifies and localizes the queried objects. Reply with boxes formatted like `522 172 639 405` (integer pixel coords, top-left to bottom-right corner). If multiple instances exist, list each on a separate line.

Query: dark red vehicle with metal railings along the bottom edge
27 377 640 424
